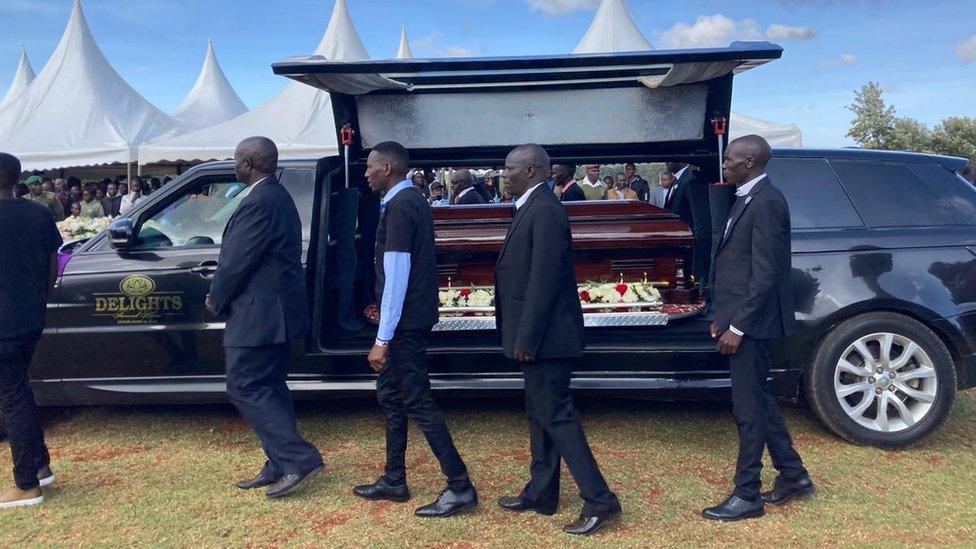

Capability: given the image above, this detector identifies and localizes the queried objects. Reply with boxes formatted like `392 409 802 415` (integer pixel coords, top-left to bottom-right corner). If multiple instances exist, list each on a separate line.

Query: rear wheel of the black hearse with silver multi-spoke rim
805 312 957 448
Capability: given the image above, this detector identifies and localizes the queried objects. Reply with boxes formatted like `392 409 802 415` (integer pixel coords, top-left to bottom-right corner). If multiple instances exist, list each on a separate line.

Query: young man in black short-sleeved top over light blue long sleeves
353 142 478 517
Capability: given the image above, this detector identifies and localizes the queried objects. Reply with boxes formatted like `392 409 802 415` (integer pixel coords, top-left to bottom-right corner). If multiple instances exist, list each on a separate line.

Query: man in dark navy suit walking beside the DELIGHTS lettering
207 137 322 498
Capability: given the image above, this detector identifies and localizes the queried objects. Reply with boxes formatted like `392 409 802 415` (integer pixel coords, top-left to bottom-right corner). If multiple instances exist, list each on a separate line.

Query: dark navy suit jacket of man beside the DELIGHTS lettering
210 177 308 347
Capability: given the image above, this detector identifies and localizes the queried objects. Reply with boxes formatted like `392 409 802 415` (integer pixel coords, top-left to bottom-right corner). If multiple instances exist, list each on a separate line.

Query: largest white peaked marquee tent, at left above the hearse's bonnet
0 0 181 170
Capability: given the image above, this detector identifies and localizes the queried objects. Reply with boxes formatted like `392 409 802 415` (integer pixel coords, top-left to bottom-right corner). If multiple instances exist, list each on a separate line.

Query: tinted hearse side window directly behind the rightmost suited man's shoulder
766 158 862 229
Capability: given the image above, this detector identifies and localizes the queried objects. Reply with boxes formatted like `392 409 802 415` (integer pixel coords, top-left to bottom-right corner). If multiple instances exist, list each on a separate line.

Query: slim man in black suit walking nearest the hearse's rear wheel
702 135 814 520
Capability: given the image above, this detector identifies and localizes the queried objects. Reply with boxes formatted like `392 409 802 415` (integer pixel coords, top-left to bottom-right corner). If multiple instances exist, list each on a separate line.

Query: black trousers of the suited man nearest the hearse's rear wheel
729 336 808 501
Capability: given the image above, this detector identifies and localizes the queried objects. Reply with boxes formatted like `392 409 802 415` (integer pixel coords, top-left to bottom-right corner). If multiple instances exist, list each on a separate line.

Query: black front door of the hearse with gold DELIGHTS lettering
47 172 247 399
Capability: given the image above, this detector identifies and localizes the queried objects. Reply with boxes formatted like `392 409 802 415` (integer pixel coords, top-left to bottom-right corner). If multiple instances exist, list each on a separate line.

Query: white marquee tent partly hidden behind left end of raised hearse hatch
139 0 369 164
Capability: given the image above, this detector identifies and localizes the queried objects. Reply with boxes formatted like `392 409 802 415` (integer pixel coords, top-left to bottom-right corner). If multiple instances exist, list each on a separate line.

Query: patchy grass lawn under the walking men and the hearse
0 392 976 548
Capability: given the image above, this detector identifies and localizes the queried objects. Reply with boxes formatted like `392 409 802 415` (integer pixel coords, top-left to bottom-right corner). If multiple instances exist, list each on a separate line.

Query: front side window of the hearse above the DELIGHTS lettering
135 178 250 250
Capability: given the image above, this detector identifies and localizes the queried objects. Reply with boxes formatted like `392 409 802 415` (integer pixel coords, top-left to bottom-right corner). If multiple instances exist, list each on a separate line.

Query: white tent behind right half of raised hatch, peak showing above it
573 0 803 147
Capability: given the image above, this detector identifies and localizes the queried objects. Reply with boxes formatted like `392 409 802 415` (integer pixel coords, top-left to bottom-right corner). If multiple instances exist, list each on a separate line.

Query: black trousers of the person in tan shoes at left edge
0 332 51 490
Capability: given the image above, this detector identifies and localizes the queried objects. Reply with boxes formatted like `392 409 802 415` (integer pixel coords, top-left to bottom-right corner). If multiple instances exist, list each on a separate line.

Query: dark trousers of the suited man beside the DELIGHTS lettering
225 343 322 479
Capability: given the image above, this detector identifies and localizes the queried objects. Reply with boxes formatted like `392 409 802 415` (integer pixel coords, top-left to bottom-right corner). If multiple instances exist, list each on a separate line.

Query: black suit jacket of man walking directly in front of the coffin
495 185 584 359
